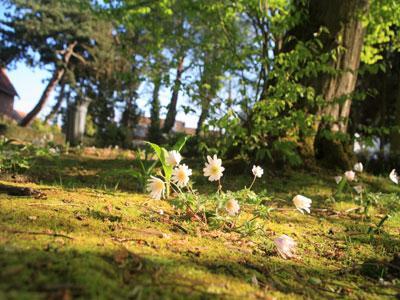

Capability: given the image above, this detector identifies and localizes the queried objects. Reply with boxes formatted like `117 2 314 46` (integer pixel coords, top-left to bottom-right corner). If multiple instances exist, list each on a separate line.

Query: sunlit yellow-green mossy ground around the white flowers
0 155 400 299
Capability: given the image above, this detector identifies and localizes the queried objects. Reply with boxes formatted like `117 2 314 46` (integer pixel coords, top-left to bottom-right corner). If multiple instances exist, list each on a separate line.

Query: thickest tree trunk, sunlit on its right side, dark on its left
285 0 369 168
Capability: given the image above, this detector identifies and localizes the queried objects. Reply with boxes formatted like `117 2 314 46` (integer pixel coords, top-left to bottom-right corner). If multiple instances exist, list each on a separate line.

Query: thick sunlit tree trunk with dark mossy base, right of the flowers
313 0 369 169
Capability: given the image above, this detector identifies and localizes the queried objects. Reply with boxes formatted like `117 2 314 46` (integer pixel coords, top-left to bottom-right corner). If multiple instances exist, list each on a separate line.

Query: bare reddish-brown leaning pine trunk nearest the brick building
19 42 77 127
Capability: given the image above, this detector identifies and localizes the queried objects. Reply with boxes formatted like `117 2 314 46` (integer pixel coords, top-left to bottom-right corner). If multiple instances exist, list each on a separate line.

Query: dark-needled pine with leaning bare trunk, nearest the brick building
0 0 103 126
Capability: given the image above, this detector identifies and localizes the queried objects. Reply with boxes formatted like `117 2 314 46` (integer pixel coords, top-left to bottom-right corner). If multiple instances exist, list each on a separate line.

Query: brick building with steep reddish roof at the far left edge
0 68 25 122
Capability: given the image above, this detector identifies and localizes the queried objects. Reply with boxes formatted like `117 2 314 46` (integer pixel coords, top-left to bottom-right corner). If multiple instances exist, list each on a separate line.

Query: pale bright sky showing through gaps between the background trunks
0 1 198 128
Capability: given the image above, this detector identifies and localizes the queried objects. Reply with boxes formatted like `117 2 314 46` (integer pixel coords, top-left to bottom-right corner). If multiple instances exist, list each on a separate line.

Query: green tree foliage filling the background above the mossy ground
0 0 400 166
